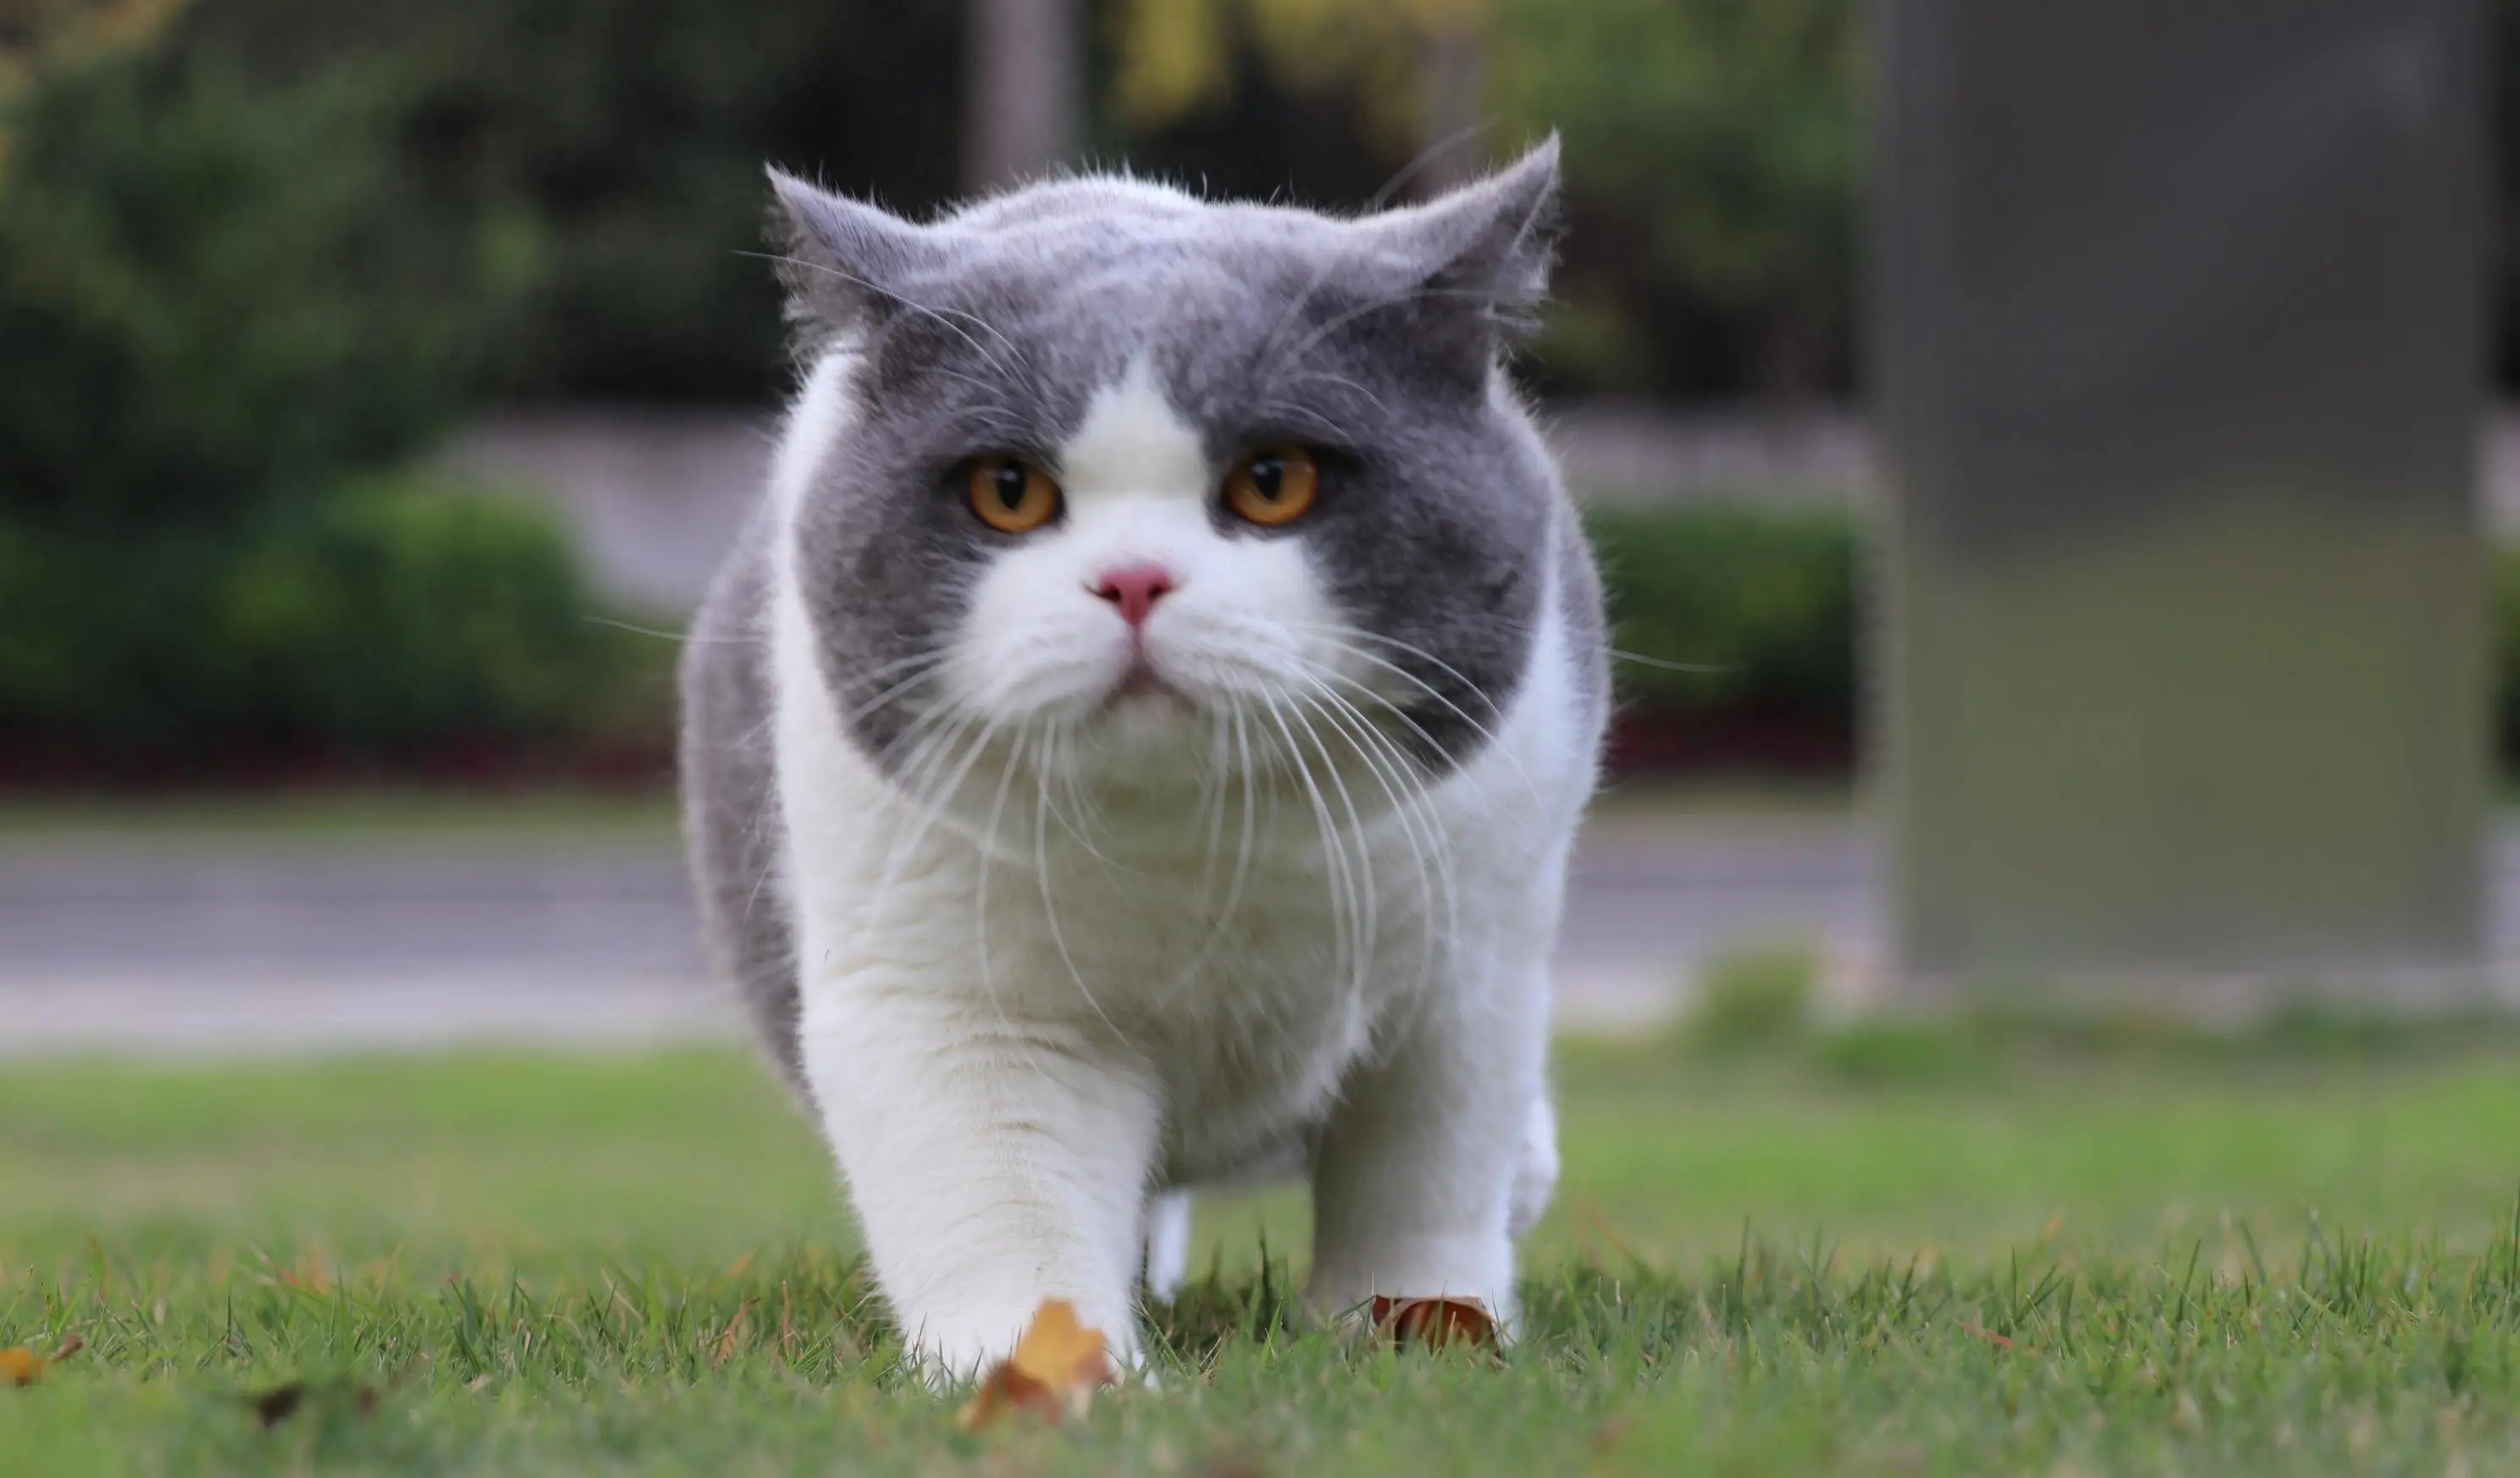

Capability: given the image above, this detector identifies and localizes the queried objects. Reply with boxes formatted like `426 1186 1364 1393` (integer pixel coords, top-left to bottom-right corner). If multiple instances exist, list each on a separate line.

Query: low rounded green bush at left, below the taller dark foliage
0 478 625 770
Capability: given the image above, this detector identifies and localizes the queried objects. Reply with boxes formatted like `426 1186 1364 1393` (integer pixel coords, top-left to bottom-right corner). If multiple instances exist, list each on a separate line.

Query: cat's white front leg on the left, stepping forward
801 982 1157 1382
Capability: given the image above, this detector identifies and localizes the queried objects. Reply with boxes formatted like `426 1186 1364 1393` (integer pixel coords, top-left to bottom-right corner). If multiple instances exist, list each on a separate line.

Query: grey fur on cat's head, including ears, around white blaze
774 139 1562 768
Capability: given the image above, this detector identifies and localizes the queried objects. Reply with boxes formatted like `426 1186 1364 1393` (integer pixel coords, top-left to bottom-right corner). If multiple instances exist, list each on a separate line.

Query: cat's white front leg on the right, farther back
1306 969 1547 1327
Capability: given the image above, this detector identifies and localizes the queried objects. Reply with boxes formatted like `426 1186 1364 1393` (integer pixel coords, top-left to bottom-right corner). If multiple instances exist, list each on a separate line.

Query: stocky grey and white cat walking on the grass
682 141 1608 1377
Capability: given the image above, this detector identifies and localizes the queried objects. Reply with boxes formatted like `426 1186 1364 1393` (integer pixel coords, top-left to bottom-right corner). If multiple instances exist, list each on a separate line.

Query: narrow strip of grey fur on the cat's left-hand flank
681 501 804 1093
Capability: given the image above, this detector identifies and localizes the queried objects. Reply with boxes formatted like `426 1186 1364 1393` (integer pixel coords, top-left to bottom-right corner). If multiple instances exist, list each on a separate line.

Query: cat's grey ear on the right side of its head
1366 134 1560 325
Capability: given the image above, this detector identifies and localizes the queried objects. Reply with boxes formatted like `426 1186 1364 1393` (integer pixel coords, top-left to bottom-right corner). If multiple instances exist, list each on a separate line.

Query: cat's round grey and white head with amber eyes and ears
776 146 1557 805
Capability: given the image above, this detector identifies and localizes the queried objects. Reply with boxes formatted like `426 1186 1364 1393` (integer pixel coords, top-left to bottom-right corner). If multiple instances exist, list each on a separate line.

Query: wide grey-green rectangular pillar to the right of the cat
1872 0 2487 1010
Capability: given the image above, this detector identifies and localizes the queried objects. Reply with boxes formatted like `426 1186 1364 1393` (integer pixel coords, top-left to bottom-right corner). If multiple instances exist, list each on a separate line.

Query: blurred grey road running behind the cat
0 816 1875 1052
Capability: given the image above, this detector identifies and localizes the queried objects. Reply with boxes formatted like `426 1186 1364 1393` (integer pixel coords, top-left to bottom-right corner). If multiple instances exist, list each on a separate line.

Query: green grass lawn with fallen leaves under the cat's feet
14 1034 2520 1478
